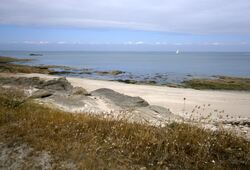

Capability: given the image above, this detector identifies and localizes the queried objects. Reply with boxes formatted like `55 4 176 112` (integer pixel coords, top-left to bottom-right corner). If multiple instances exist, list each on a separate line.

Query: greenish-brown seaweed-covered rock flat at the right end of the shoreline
184 76 250 90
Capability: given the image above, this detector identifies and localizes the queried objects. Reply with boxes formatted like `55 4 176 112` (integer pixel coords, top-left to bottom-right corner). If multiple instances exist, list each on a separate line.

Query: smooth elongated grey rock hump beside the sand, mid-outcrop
91 88 149 108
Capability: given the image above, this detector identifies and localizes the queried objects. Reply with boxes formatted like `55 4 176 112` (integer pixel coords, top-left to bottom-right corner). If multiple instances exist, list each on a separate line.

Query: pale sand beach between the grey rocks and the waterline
14 74 250 118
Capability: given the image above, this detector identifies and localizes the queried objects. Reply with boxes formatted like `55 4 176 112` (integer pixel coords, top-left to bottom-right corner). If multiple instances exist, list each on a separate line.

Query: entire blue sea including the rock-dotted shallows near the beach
0 51 250 86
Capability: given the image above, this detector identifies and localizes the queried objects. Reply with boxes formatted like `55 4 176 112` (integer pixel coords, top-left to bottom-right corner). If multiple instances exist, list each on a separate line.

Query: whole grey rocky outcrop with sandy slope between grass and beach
0 77 181 125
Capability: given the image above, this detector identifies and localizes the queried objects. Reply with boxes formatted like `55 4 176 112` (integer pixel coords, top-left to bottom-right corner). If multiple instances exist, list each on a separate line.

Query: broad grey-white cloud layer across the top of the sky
0 0 250 35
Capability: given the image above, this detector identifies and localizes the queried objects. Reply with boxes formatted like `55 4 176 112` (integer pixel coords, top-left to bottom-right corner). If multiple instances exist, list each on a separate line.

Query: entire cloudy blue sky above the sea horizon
0 0 250 51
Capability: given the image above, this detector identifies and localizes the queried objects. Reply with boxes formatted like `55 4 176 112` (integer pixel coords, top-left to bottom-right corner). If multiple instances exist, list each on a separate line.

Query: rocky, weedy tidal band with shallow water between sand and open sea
0 56 250 91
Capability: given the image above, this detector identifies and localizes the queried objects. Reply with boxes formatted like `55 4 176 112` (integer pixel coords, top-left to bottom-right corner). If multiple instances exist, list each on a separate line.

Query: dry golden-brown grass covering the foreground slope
0 88 250 169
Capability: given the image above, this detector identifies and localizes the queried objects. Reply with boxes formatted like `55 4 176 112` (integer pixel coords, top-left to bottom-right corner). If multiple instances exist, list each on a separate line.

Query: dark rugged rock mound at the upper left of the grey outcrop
41 77 73 91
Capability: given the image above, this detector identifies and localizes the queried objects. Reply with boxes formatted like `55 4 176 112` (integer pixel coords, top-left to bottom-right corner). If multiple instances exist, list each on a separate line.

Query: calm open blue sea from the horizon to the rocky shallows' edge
0 51 250 83
